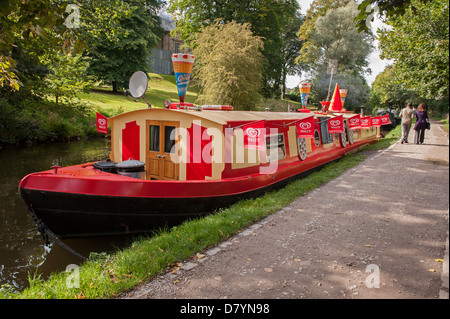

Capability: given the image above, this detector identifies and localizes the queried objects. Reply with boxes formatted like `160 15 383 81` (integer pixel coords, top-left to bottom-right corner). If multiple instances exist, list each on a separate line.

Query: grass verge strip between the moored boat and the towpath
0 127 400 299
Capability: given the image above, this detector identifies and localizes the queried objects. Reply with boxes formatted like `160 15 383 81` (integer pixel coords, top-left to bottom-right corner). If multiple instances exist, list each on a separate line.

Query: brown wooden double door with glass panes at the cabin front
146 121 179 180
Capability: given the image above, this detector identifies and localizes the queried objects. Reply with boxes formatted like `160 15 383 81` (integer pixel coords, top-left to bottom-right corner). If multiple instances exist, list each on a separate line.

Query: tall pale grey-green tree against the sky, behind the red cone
297 0 373 109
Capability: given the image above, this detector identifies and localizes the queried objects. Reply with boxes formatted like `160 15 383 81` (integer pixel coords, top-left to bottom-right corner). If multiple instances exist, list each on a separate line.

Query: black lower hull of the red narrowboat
19 170 313 238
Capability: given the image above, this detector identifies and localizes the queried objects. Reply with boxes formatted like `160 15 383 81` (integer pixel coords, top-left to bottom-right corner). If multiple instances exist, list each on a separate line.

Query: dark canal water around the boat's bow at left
0 138 131 290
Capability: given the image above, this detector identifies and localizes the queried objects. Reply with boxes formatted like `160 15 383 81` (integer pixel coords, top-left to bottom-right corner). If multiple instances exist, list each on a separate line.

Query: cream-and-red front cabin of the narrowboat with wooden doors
110 109 322 181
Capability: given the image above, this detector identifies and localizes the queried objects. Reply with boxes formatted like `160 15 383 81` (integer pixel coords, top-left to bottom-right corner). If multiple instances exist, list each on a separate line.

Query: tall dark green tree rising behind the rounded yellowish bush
168 0 299 97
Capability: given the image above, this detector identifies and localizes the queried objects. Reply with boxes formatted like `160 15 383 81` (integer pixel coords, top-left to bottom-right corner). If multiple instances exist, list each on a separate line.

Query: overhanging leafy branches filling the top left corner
0 0 129 90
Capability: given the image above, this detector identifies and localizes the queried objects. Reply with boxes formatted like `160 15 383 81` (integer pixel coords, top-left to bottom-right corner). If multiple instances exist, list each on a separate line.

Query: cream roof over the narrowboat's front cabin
110 108 314 125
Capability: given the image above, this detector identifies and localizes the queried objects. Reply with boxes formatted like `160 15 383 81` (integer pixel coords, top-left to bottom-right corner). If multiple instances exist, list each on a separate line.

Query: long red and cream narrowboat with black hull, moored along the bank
19 106 379 238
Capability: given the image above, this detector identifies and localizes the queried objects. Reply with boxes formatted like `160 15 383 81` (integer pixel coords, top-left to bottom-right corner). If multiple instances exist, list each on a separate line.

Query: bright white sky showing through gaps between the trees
286 0 389 88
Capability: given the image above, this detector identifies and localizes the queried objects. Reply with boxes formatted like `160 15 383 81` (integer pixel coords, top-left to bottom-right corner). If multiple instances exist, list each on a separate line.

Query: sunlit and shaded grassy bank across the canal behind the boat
0 73 197 148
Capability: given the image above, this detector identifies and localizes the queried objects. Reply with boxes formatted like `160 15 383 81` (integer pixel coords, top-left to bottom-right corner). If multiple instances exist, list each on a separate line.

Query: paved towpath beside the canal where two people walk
122 121 449 299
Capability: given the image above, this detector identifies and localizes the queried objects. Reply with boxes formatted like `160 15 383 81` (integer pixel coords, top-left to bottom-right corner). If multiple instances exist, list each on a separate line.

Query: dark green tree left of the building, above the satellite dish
87 0 162 92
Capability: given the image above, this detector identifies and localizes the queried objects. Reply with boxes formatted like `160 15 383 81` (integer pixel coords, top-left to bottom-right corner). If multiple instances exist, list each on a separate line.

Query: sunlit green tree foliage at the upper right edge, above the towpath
378 0 449 100
